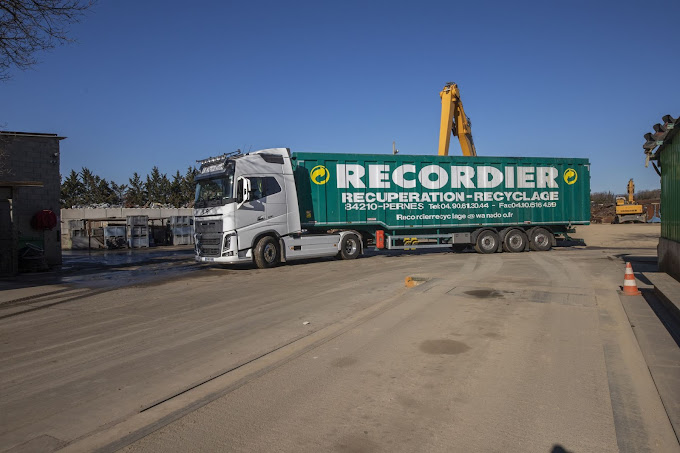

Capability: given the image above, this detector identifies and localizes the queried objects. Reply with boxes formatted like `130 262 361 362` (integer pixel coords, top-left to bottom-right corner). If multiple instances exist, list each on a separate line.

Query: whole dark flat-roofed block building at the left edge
0 131 65 275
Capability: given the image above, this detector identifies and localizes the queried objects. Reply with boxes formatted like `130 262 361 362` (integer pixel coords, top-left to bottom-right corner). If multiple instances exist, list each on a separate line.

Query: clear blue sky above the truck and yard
0 0 680 193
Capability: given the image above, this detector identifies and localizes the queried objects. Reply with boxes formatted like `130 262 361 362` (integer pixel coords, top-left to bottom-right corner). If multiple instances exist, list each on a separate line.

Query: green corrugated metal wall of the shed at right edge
661 134 680 242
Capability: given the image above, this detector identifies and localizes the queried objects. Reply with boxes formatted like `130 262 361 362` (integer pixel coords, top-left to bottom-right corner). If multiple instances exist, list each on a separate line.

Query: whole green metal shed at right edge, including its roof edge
642 115 680 281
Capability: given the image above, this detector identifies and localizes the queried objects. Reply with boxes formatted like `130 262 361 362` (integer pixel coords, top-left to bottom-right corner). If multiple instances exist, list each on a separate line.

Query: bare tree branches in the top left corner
0 0 96 80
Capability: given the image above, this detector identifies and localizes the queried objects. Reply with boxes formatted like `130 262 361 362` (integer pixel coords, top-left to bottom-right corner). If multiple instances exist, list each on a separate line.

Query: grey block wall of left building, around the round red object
0 132 62 265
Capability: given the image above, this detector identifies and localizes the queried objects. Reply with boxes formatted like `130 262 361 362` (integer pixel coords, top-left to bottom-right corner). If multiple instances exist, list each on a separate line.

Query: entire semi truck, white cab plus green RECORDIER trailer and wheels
195 148 590 267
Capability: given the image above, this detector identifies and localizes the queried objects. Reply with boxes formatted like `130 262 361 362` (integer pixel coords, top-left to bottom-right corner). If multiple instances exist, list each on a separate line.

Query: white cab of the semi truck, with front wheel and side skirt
194 148 360 268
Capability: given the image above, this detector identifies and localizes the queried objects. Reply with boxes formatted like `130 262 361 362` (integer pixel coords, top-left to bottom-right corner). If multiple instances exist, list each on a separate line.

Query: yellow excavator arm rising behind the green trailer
439 82 477 156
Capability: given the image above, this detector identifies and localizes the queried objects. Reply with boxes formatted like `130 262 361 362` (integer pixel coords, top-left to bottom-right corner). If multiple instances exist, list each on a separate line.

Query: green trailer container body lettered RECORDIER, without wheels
292 153 590 232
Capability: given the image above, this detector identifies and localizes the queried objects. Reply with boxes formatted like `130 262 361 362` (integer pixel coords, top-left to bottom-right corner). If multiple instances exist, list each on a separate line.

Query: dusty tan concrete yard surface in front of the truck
0 225 680 452
